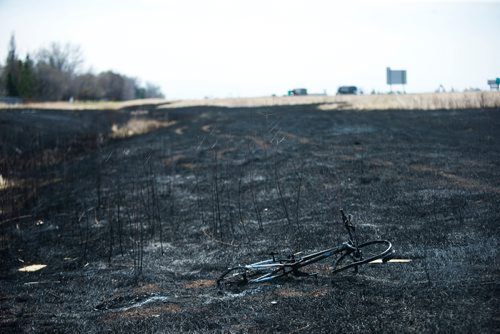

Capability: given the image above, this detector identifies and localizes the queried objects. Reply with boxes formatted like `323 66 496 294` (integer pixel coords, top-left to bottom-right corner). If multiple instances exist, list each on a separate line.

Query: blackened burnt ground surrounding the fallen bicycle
0 105 500 333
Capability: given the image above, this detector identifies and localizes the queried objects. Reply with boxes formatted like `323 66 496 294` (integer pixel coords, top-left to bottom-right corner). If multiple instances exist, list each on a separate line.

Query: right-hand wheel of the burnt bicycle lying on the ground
332 240 392 274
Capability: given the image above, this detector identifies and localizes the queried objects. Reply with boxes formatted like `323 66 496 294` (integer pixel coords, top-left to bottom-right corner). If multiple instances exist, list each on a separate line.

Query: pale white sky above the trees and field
0 0 500 99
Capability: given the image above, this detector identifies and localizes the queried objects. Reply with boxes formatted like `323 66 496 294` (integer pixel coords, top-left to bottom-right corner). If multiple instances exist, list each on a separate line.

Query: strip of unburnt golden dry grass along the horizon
0 91 500 110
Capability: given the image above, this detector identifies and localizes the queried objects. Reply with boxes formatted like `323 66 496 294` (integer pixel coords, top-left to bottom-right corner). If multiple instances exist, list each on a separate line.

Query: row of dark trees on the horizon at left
0 36 164 101
